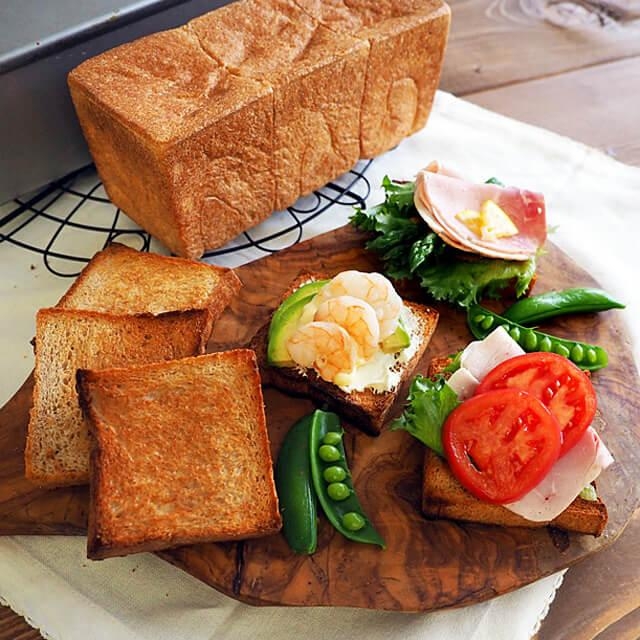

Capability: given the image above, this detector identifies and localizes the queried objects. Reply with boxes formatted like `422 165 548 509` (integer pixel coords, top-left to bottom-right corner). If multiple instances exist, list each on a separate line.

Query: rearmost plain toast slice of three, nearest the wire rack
57 242 242 333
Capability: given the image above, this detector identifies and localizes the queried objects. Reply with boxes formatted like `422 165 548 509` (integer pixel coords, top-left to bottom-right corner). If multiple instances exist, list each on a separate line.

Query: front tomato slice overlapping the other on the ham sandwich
442 389 561 504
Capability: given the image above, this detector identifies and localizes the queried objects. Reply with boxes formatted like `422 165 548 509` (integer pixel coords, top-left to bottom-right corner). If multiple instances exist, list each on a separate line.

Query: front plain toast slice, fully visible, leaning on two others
77 349 281 559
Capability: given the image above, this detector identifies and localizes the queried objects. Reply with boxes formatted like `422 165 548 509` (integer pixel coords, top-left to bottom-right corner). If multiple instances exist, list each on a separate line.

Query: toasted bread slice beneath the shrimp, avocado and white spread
250 274 438 435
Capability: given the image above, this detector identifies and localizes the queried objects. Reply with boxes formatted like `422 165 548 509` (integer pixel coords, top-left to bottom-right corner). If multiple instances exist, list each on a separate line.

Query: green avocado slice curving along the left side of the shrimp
267 280 329 367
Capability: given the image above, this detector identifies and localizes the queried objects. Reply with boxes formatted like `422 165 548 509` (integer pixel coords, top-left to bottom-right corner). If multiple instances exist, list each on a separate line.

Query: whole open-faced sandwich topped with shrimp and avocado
252 271 438 435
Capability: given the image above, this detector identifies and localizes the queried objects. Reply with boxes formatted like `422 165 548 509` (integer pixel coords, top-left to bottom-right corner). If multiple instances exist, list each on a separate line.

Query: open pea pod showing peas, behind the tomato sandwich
467 305 609 371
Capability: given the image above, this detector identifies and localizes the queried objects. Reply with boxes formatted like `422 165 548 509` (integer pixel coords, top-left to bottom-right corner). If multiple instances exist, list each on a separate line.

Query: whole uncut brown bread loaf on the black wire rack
69 0 449 257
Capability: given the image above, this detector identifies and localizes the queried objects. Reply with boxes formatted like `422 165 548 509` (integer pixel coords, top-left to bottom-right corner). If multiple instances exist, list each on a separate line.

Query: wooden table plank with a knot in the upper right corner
440 0 640 95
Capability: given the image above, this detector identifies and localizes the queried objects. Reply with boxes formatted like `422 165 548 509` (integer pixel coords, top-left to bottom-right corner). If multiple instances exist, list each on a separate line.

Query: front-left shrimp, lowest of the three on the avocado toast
287 322 358 382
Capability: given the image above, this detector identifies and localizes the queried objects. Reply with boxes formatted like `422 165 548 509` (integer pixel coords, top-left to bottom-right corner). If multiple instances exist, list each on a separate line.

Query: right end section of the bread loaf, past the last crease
296 0 450 158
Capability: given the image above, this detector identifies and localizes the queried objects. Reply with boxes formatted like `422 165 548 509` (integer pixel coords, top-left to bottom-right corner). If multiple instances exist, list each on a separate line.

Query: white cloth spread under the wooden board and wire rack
0 93 640 640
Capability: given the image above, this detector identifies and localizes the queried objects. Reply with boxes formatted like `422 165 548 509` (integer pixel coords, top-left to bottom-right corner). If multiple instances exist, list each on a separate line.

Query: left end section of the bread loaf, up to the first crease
69 28 275 258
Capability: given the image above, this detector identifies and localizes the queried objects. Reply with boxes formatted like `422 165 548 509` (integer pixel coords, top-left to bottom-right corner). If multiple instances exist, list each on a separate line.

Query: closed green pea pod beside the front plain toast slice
275 414 318 554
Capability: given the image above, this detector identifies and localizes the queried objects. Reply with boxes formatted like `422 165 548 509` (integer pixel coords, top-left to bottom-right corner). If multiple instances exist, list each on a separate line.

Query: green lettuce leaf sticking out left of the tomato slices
391 375 459 457
